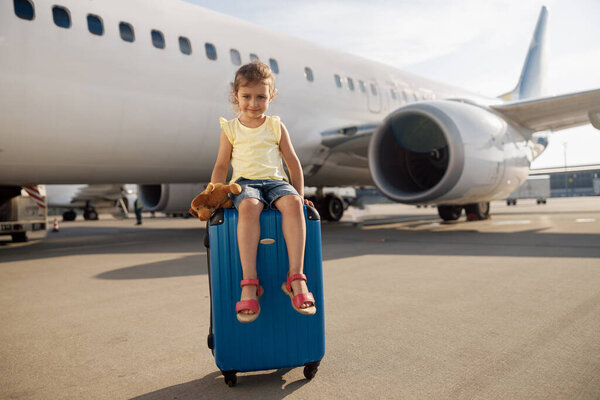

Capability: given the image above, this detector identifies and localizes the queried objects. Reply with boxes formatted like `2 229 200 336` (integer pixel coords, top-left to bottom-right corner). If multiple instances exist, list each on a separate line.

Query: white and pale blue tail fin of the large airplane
498 6 548 101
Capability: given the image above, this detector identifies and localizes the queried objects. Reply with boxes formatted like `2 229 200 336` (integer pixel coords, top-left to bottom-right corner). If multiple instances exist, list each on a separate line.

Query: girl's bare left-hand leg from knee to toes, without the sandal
237 198 264 314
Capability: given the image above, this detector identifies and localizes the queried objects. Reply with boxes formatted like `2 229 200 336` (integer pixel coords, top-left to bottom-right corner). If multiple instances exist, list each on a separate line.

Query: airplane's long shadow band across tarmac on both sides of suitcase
0 219 600 280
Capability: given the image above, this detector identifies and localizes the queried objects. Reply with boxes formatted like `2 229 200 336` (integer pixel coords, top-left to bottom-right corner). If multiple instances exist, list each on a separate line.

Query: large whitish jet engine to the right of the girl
369 100 533 204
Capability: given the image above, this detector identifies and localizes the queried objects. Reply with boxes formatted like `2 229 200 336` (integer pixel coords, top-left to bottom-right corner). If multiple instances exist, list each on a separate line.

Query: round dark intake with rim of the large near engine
369 103 464 203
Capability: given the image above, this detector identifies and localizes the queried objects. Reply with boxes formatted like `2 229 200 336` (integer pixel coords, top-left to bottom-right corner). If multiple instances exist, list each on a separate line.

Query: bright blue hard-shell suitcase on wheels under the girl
205 207 325 386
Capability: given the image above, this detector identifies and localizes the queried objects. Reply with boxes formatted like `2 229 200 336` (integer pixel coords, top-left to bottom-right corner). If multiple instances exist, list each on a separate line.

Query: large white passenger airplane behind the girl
0 0 600 221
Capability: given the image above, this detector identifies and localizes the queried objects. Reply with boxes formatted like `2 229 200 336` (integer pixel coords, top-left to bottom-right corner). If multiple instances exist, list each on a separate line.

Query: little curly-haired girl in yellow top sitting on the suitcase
211 61 317 322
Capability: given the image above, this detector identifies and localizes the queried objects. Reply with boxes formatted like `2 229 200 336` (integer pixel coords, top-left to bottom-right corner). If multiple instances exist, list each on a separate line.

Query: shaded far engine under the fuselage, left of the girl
138 183 206 214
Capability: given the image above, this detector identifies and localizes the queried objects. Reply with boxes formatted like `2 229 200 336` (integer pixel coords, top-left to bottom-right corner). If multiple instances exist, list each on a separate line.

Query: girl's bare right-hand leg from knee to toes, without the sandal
274 195 312 308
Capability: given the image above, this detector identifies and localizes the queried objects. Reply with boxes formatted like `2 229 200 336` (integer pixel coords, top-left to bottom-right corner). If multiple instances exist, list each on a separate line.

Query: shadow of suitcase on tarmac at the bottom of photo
131 368 309 400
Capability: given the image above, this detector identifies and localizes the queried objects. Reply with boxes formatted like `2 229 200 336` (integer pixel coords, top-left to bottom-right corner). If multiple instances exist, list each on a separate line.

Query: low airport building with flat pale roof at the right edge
529 165 600 197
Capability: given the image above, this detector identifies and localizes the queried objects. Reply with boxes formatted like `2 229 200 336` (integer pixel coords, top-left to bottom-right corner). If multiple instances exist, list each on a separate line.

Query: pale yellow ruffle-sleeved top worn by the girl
219 116 288 183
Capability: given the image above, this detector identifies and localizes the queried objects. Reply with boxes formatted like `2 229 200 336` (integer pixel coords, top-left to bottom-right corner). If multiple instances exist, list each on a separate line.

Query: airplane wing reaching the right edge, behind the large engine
491 89 600 132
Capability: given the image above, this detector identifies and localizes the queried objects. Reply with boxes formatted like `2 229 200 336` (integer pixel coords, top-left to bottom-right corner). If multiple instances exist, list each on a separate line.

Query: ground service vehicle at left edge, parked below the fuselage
0 185 48 242
